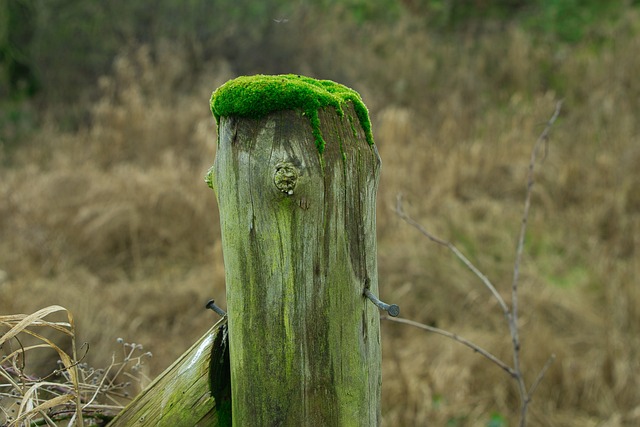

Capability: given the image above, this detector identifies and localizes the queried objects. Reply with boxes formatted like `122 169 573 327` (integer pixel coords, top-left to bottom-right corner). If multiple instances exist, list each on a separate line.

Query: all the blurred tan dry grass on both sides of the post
0 10 640 427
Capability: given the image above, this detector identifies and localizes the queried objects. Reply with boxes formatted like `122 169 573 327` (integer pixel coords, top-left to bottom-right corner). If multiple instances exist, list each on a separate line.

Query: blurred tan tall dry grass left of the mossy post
0 44 230 382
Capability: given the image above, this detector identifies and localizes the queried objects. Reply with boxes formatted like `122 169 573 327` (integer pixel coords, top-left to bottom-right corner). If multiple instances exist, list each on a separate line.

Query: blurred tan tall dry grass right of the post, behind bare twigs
375 13 640 426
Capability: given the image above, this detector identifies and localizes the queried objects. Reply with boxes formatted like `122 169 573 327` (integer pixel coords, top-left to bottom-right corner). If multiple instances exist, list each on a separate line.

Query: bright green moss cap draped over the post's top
211 74 373 153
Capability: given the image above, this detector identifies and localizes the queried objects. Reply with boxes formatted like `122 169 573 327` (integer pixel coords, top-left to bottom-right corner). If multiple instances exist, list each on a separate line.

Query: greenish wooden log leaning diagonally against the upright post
109 318 231 427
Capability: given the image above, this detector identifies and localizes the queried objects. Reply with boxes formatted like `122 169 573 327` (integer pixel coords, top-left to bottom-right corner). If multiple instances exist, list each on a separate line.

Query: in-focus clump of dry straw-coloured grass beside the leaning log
0 305 151 426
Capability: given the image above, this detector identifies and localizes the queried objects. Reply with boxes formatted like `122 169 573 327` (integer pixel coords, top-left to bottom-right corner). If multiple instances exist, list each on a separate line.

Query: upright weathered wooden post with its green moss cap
209 75 381 426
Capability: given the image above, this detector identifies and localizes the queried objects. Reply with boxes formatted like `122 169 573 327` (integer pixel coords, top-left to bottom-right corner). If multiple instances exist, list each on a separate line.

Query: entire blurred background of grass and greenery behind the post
0 0 640 426
